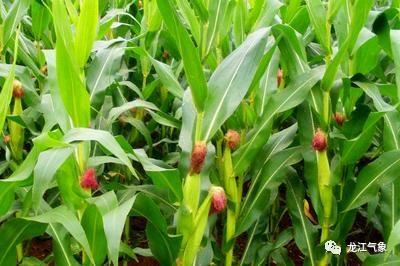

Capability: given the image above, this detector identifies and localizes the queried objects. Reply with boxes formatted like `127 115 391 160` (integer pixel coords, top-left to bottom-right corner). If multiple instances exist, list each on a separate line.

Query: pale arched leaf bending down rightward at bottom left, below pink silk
24 205 94 263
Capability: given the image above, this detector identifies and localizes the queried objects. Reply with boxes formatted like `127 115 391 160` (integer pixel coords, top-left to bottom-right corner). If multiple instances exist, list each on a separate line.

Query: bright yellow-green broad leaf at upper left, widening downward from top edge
53 0 90 127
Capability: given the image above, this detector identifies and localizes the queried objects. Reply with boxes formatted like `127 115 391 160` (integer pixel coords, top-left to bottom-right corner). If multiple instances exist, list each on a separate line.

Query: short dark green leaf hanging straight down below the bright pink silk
81 205 107 265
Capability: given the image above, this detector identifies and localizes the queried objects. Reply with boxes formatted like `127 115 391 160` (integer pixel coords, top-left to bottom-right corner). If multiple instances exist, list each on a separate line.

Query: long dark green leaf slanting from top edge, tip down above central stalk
157 0 208 112
